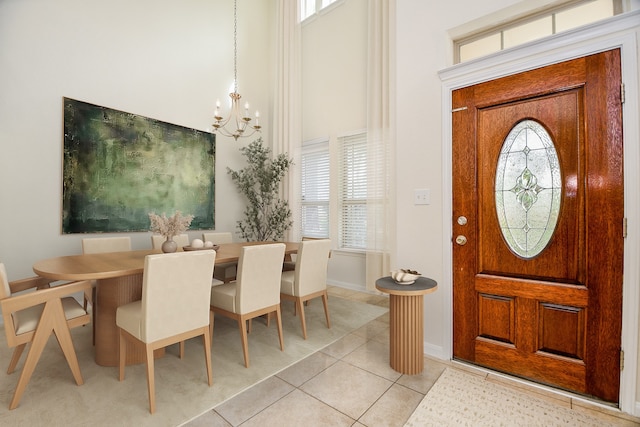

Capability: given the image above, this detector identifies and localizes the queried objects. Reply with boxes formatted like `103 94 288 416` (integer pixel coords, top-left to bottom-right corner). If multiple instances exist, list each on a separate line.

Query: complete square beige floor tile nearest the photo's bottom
300 361 393 420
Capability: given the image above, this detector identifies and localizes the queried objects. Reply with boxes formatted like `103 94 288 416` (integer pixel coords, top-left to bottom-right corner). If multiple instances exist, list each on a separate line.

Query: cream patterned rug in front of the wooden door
405 368 609 427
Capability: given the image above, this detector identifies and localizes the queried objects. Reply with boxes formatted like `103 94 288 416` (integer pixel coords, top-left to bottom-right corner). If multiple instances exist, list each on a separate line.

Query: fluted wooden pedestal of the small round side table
389 294 424 375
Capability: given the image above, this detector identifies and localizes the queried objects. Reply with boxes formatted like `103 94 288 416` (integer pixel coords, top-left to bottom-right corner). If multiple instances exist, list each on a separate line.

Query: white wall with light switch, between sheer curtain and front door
396 0 528 357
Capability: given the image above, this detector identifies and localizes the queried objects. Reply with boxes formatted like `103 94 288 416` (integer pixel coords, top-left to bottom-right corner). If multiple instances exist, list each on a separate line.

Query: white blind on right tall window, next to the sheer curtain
339 132 367 249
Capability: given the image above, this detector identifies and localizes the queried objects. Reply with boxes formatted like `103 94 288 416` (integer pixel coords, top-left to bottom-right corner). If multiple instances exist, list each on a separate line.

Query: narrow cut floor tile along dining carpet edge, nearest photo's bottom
215 377 295 426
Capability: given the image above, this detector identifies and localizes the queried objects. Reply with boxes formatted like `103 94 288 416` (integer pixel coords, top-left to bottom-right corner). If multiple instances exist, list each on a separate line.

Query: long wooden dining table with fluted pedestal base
33 242 298 366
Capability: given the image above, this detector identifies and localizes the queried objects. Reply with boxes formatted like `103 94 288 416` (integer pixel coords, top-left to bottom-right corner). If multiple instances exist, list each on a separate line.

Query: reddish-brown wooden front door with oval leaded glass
452 50 624 402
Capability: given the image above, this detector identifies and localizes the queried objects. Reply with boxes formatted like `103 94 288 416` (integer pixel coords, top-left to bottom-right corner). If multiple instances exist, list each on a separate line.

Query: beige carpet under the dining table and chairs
0 296 387 426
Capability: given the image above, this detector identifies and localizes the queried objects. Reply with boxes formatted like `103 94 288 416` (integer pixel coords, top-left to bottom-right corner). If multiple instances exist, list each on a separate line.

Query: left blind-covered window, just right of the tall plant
300 140 330 238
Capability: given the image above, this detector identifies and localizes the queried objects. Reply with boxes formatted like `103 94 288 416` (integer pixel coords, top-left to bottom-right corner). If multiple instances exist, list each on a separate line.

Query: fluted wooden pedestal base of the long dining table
93 274 164 366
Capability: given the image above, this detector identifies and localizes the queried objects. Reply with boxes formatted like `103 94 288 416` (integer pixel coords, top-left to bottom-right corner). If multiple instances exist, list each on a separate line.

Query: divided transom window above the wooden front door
455 0 623 63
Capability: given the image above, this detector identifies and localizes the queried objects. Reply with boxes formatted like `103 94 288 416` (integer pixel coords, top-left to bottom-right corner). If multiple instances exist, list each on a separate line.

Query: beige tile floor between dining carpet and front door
185 287 640 427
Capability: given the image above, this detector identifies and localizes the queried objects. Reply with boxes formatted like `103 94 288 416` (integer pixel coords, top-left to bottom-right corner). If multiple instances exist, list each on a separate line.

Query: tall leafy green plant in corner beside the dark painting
227 138 293 241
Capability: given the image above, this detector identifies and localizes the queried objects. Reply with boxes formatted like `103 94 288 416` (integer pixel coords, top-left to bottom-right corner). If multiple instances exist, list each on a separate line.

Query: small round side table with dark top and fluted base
376 276 438 375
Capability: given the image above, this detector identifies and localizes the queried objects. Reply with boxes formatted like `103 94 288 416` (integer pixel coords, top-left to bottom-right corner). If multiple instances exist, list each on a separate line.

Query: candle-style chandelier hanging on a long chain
212 0 261 141
